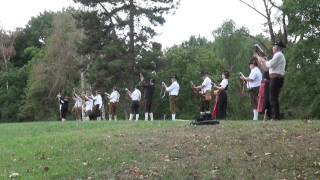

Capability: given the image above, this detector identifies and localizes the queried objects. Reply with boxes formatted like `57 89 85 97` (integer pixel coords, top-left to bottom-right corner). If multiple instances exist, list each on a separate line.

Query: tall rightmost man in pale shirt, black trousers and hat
256 41 286 120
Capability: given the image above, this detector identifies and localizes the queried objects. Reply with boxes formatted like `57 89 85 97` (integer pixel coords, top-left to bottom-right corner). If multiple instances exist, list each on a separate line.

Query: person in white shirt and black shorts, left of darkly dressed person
126 86 141 121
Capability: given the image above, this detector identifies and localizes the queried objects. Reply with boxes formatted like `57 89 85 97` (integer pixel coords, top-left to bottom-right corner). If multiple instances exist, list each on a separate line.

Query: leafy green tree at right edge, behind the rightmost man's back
282 0 320 118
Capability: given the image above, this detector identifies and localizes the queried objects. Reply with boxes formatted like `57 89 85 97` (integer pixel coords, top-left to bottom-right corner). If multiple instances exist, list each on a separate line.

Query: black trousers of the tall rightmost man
269 77 284 120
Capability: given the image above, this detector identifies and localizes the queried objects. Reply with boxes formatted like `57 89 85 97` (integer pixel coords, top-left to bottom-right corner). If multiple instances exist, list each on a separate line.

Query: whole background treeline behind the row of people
0 0 320 122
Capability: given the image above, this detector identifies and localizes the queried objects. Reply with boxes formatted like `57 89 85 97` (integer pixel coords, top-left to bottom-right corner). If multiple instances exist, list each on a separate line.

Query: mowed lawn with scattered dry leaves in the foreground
0 121 320 180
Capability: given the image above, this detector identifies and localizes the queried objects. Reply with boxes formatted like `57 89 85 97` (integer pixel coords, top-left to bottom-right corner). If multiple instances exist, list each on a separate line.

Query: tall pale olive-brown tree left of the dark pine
21 11 83 119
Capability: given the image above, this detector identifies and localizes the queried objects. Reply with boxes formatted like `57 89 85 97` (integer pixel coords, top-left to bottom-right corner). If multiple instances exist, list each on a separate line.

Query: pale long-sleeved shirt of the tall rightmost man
266 51 286 75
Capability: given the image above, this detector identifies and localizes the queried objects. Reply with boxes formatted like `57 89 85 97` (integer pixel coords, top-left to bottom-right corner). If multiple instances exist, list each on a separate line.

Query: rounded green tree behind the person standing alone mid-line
155 37 224 118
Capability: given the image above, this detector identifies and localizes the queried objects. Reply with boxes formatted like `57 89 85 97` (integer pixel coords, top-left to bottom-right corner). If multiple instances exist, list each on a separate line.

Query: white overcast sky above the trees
0 0 264 47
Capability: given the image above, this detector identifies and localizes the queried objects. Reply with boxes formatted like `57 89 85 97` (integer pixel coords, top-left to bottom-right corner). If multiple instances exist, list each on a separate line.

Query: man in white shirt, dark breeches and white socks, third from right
240 57 262 120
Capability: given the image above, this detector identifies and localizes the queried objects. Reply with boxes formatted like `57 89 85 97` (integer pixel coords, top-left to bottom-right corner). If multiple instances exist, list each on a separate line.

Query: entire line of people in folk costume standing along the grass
57 43 286 121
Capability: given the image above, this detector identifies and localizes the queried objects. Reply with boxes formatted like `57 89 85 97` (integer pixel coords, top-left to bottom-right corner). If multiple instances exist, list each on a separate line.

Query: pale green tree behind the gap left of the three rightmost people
212 20 268 119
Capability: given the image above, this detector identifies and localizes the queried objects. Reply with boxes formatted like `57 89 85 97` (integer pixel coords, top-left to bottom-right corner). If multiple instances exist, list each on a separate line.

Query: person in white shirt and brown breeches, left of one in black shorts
105 86 120 121
